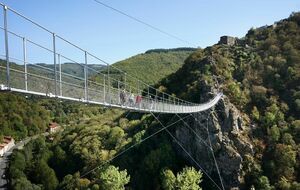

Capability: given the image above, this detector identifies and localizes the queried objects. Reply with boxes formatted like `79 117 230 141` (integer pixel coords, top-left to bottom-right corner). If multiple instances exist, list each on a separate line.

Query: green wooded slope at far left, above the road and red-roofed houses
0 93 51 140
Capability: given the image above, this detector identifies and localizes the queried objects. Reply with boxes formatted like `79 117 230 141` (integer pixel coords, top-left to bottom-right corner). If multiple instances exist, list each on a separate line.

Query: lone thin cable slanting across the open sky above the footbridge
93 0 197 47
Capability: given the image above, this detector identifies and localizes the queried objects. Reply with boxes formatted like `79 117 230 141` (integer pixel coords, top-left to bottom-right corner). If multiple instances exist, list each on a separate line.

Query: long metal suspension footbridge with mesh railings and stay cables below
0 3 224 189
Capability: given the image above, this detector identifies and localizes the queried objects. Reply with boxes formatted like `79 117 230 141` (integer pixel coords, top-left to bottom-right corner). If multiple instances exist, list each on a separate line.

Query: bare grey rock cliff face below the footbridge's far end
175 94 253 189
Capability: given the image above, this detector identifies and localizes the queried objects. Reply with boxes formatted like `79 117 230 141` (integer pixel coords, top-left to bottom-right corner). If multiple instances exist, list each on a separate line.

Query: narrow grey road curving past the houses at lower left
0 132 49 190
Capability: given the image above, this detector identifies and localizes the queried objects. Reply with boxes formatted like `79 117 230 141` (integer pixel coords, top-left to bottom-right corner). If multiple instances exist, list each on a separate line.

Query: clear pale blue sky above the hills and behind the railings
0 0 300 63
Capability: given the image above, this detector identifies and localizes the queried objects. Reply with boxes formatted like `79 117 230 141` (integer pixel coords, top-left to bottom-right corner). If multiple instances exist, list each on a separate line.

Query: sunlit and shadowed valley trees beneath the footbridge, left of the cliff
9 102 202 190
